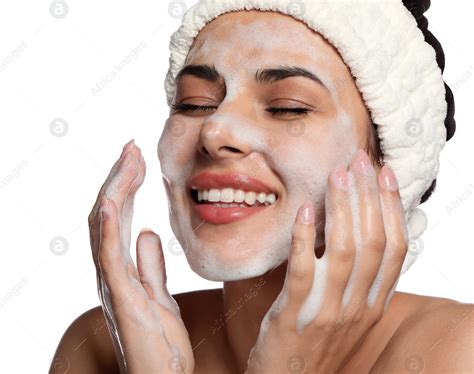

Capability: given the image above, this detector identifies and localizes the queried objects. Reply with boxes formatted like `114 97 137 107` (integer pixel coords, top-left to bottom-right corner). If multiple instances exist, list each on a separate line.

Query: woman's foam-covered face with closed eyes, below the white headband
158 10 370 281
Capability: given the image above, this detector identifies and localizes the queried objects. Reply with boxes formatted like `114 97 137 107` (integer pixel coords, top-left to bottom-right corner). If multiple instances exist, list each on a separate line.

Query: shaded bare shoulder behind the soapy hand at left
49 306 118 374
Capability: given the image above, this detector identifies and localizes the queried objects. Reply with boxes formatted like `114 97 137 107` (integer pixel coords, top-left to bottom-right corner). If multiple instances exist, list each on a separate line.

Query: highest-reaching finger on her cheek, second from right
345 150 386 310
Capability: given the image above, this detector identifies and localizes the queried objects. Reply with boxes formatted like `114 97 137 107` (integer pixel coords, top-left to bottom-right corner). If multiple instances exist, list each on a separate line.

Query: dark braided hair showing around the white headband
367 0 456 204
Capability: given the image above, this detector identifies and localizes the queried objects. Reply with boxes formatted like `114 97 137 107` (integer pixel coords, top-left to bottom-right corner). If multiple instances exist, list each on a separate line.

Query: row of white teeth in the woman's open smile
193 187 276 207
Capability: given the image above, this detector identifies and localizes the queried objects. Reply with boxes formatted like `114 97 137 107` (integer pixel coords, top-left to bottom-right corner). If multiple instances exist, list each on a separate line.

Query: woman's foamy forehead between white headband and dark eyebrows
186 10 346 83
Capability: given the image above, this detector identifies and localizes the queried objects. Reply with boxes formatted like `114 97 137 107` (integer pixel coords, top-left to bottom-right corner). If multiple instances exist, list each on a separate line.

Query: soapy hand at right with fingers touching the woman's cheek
246 151 408 374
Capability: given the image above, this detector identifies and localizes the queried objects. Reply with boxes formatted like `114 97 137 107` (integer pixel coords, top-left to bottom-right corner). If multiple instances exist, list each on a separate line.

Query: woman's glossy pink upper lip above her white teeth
188 172 276 195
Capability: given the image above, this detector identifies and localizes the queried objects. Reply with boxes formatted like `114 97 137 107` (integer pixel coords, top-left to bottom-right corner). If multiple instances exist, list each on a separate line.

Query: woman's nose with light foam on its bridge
198 111 252 160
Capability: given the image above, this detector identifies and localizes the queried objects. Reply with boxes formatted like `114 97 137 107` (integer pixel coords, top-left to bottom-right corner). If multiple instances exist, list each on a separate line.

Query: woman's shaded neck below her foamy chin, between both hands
223 261 287 373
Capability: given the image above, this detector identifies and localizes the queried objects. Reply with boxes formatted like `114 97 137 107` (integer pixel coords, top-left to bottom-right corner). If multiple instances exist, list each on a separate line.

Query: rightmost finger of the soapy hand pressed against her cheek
369 166 408 307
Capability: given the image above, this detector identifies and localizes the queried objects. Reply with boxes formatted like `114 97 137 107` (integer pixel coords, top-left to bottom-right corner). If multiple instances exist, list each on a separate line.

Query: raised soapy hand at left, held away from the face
89 141 194 374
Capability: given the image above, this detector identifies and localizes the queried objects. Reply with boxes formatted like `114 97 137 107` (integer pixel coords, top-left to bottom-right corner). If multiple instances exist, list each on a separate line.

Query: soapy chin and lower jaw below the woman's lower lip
170 187 320 282
